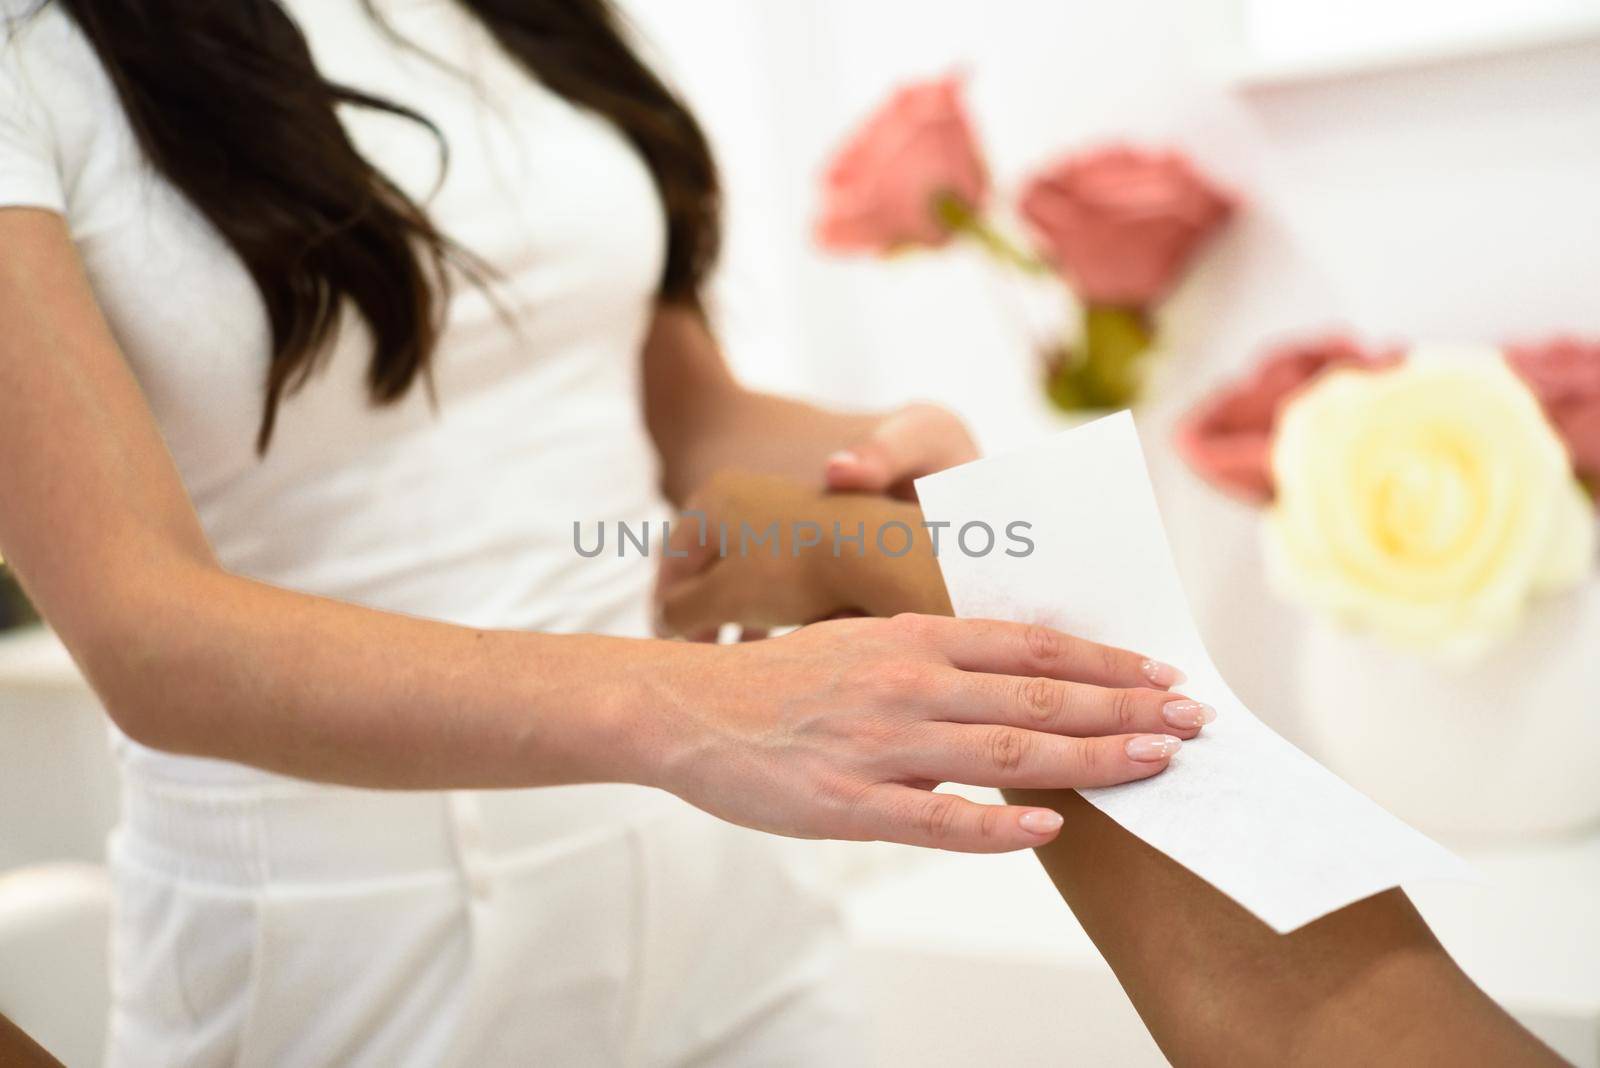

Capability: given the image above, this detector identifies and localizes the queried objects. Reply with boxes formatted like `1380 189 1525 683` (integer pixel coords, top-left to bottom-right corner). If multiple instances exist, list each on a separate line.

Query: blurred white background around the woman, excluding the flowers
9 0 1600 1066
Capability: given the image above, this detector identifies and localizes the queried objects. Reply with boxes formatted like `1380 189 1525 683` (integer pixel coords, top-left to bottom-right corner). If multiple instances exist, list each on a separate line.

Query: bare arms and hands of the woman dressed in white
0 208 1203 852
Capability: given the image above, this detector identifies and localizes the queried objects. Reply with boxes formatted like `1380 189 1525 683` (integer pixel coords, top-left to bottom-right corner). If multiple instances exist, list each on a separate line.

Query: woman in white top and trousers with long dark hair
0 0 1209 1065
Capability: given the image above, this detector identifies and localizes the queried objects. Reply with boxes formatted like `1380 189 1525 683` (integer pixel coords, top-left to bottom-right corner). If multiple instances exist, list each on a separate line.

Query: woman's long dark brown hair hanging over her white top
42 0 718 451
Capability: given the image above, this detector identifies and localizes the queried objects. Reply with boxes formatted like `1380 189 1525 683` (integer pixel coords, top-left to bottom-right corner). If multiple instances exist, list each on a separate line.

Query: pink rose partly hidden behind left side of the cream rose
1176 336 1400 502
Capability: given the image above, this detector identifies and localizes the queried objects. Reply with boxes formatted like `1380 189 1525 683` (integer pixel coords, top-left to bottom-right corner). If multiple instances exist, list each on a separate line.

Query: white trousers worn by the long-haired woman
109 772 861 1068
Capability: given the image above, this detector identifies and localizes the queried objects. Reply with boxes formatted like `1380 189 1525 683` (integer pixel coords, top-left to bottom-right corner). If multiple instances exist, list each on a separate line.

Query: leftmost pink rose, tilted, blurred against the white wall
816 75 989 253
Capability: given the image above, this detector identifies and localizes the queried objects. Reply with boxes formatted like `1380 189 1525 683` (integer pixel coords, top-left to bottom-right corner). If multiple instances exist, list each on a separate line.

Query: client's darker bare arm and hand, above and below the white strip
662 475 1563 1068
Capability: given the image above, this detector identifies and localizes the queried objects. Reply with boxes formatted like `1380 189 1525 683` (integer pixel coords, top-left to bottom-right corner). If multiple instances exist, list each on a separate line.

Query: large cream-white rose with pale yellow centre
1267 345 1595 656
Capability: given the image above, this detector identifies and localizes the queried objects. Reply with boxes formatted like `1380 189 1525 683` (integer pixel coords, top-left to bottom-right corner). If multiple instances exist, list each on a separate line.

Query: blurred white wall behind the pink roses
635 0 1600 741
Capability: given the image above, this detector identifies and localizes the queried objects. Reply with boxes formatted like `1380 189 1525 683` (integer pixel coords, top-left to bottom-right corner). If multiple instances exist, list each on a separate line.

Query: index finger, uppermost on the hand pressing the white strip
915 616 1184 689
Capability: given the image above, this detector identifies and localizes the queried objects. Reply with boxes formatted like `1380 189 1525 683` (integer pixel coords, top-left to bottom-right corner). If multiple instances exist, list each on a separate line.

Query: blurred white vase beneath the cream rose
1299 580 1600 844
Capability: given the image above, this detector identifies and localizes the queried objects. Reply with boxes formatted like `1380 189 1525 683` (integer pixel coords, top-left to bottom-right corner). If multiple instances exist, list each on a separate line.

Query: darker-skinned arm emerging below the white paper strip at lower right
1006 790 1560 1065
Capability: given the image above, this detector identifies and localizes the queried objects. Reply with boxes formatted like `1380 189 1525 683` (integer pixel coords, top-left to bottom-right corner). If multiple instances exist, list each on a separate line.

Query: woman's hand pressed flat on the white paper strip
650 616 1205 852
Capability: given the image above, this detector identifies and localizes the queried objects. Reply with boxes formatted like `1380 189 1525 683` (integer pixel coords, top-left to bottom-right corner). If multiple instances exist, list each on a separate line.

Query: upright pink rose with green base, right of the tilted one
1021 147 1234 309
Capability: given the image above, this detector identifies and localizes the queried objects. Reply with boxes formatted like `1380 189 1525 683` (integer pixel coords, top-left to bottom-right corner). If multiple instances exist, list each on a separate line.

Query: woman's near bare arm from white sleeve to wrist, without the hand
0 209 688 787
